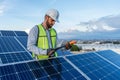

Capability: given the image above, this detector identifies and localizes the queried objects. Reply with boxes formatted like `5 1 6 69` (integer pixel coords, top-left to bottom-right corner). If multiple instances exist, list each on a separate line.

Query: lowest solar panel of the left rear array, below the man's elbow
0 52 33 64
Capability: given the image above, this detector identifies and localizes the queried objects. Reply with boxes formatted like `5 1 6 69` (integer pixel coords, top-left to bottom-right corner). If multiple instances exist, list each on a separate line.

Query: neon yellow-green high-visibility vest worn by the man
32 24 57 59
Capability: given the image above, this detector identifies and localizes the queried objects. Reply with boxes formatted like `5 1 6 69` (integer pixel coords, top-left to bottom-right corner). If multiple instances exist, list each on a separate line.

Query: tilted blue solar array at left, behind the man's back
0 31 33 65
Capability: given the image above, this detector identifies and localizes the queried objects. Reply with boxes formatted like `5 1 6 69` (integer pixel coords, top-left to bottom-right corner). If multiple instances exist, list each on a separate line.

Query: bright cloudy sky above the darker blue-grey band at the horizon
0 0 120 37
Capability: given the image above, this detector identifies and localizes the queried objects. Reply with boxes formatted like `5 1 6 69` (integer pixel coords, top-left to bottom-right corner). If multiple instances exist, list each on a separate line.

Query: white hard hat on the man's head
46 9 59 22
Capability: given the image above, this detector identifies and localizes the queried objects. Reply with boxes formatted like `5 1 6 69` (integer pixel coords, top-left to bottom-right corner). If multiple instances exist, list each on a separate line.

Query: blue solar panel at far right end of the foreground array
97 50 120 67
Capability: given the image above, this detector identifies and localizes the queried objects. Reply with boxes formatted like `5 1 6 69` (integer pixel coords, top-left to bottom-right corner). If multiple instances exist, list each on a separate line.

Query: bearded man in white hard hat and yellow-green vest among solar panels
27 9 70 60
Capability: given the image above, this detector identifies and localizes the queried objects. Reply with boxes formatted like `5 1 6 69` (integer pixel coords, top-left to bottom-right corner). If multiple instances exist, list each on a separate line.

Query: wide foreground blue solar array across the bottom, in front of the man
0 50 120 80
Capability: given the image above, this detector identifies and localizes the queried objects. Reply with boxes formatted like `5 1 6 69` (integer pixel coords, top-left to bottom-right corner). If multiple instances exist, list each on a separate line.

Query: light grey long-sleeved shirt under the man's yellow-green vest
27 25 62 54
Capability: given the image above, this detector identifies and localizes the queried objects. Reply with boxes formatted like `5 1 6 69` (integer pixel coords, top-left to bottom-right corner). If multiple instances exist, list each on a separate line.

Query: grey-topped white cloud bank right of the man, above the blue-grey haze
58 15 120 32
